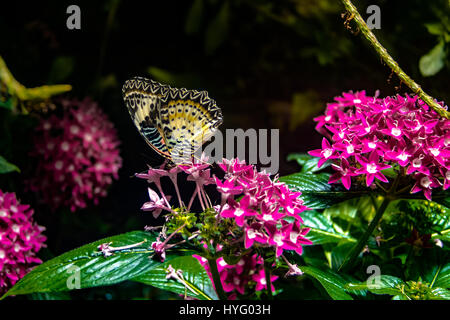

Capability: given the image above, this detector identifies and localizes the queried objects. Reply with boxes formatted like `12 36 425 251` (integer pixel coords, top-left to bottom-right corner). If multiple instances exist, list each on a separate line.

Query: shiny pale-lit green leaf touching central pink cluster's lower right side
301 210 356 245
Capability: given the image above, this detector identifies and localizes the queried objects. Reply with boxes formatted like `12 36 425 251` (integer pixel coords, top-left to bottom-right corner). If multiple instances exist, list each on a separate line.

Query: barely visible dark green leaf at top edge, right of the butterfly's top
205 1 230 55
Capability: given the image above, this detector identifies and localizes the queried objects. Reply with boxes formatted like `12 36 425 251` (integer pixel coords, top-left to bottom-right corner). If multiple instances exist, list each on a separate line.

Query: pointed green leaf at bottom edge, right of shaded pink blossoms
300 266 353 300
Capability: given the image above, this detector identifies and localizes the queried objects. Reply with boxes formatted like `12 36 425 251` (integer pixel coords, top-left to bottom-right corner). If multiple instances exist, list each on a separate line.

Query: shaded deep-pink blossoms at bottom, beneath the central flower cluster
193 254 278 300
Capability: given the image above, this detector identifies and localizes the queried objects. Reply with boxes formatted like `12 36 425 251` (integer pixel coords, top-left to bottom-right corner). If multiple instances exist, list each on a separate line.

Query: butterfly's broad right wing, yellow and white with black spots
157 88 222 164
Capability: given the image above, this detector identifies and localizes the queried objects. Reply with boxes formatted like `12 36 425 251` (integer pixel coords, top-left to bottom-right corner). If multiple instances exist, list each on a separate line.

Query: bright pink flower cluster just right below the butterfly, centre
215 159 312 257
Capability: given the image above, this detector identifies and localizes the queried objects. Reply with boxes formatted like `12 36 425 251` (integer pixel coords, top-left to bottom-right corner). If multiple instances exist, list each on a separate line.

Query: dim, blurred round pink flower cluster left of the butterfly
29 98 122 211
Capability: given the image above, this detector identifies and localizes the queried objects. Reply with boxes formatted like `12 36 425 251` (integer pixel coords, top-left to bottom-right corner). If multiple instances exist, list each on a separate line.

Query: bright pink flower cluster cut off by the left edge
0 190 46 296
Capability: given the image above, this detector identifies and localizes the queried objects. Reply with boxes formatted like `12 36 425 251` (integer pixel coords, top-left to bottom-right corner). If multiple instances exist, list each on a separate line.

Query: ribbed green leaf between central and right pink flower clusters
280 173 367 209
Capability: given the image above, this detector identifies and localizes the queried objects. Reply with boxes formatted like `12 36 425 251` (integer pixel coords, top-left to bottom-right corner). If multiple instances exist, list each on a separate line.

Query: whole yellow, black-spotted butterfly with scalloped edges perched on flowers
122 77 223 164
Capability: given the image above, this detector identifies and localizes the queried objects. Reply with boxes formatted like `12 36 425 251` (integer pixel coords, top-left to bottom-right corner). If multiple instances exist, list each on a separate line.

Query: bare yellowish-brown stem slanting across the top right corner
341 0 450 119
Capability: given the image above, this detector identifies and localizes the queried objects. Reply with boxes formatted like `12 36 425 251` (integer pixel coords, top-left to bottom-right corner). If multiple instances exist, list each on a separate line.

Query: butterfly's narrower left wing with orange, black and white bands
122 77 170 159
